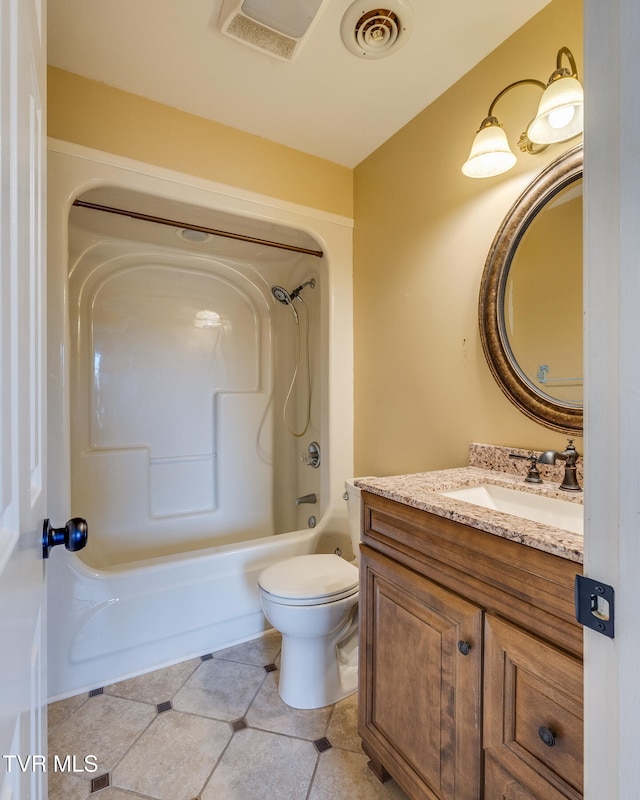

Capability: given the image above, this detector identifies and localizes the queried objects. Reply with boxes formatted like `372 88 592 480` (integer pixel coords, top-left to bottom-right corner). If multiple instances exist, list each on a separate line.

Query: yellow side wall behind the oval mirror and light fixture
354 0 583 475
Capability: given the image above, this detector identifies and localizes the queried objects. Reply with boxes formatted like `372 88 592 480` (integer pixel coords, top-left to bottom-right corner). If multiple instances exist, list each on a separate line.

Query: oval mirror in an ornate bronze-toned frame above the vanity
479 145 583 435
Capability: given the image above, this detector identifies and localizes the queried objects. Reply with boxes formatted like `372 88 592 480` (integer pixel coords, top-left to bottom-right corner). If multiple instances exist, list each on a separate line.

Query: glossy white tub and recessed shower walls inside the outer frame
48 145 350 698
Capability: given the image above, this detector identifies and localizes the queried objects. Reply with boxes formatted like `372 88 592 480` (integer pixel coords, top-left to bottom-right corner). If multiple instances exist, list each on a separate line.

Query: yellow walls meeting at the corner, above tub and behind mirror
48 0 583 482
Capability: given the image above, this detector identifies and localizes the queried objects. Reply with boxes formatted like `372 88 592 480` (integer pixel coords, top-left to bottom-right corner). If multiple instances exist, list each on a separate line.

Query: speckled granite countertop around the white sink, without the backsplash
355 466 583 564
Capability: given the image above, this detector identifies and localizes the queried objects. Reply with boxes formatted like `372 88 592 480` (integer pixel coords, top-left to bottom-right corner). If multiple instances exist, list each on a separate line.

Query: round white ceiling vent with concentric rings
340 0 413 59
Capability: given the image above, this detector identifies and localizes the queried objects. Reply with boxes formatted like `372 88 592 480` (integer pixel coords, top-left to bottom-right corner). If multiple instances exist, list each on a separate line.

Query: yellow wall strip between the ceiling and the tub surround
47 67 353 217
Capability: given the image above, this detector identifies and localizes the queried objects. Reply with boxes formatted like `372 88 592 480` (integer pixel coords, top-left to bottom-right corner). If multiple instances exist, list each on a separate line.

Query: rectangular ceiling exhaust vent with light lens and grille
218 0 326 61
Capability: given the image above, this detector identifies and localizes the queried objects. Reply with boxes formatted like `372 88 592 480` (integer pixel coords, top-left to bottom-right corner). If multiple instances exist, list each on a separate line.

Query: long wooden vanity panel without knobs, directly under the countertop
362 491 582 657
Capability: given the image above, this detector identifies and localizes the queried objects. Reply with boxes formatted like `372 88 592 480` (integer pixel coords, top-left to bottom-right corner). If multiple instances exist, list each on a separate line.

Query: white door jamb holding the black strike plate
584 0 640 800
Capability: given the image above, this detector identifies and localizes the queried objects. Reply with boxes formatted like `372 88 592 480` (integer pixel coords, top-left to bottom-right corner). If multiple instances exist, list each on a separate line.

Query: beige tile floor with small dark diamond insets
48 634 406 800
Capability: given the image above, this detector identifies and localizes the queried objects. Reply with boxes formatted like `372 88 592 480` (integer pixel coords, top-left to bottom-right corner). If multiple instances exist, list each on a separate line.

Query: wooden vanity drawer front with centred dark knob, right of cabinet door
484 614 583 799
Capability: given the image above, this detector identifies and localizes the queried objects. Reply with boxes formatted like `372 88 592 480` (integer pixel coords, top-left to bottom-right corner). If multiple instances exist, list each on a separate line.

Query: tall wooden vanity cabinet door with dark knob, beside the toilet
359 546 483 800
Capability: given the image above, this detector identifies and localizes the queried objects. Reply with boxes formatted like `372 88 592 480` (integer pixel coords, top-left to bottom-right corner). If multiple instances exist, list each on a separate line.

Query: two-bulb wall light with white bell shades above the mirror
462 47 584 178
